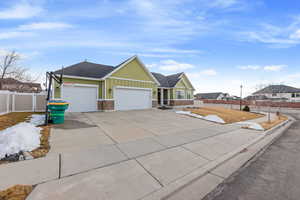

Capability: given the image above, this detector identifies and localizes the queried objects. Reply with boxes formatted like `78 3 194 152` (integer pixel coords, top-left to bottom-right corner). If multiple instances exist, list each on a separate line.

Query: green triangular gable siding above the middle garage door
111 59 154 81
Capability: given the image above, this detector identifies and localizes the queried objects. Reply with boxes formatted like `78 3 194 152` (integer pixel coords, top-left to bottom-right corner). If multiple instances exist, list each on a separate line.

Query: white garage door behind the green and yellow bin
62 85 98 112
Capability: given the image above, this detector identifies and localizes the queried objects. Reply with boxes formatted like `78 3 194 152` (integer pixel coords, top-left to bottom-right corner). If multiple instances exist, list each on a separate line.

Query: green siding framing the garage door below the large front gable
105 78 157 100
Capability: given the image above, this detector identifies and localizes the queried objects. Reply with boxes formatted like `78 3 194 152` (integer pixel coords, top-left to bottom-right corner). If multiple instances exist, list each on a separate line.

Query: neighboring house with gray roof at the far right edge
251 85 300 102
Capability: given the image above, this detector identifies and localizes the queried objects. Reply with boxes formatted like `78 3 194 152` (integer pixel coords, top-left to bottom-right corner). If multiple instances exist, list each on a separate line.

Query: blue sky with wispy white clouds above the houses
0 0 300 95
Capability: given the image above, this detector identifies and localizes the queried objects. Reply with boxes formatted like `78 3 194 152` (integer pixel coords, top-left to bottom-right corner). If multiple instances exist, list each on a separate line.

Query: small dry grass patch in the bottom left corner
0 185 32 200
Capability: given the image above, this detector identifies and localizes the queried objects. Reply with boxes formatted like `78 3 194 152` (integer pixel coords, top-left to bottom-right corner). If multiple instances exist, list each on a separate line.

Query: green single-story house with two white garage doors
53 56 194 112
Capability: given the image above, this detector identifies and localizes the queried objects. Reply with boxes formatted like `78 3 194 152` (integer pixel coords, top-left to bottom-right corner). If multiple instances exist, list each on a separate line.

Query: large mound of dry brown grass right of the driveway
185 107 264 124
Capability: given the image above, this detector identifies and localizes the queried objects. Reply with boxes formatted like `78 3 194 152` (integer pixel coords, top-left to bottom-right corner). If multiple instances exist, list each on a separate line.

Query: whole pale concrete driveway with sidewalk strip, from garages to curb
0 110 268 200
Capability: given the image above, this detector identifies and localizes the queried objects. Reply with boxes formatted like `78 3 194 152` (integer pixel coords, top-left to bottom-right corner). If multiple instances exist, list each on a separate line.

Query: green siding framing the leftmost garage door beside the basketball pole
54 78 104 99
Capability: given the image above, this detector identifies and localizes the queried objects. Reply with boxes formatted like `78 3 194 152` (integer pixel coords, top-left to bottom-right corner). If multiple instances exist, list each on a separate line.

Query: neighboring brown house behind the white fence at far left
0 78 42 93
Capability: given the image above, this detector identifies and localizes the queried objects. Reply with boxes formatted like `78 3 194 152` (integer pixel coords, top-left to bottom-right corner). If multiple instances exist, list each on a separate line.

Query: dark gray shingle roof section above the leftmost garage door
54 61 116 78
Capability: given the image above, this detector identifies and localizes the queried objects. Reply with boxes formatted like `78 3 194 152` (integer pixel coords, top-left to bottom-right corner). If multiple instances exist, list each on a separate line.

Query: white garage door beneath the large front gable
114 88 152 110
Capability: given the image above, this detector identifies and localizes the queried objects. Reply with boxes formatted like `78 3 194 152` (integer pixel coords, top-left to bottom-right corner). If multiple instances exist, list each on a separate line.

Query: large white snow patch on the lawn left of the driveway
0 122 42 159
